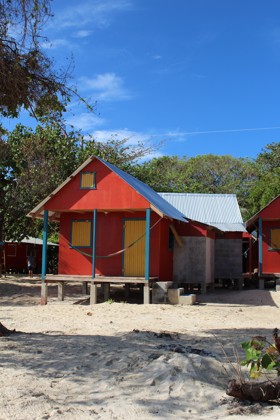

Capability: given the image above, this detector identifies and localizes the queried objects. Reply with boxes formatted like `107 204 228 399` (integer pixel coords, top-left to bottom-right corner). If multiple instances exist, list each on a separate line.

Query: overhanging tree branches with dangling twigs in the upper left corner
0 0 82 120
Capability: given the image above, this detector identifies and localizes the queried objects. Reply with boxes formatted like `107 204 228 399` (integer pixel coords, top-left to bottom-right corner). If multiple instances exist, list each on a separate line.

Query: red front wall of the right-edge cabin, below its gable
262 220 280 274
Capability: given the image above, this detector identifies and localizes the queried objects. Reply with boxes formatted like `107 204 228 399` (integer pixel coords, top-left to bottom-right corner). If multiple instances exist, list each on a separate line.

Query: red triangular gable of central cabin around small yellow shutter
45 159 150 211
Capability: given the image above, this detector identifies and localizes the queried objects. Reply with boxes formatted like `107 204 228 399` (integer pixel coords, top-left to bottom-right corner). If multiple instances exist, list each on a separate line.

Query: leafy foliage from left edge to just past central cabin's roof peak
0 123 155 249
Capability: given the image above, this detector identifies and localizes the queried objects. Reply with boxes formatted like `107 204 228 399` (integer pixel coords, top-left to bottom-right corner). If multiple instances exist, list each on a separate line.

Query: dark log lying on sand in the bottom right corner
226 379 280 402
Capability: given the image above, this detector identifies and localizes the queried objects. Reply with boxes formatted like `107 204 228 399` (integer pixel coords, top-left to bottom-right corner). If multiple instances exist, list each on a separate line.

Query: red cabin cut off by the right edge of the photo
246 195 280 278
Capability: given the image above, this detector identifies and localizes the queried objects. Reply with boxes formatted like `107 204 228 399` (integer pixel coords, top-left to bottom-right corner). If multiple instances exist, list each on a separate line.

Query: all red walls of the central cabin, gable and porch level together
45 159 179 280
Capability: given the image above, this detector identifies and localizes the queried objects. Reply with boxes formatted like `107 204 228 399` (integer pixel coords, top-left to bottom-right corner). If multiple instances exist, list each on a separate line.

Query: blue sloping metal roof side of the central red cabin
96 157 187 223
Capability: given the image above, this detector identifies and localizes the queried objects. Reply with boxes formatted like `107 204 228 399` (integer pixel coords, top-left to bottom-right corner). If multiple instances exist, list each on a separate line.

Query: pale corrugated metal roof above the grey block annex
159 193 246 232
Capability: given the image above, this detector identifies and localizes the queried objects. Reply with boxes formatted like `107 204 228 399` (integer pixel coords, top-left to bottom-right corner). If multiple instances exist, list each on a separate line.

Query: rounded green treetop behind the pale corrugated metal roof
137 155 257 218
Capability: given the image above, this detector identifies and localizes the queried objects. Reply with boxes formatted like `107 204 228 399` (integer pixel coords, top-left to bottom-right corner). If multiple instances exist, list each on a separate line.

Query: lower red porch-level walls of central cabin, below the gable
58 212 173 281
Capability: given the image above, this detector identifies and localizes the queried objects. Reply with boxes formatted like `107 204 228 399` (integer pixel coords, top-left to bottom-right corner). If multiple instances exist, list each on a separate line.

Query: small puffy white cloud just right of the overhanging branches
79 73 131 101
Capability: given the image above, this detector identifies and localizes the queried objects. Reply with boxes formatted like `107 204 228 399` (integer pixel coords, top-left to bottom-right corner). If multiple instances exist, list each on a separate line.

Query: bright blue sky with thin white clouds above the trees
8 0 280 158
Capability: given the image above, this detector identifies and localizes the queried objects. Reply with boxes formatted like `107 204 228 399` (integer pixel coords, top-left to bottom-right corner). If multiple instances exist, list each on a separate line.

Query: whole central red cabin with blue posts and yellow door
29 157 187 288
